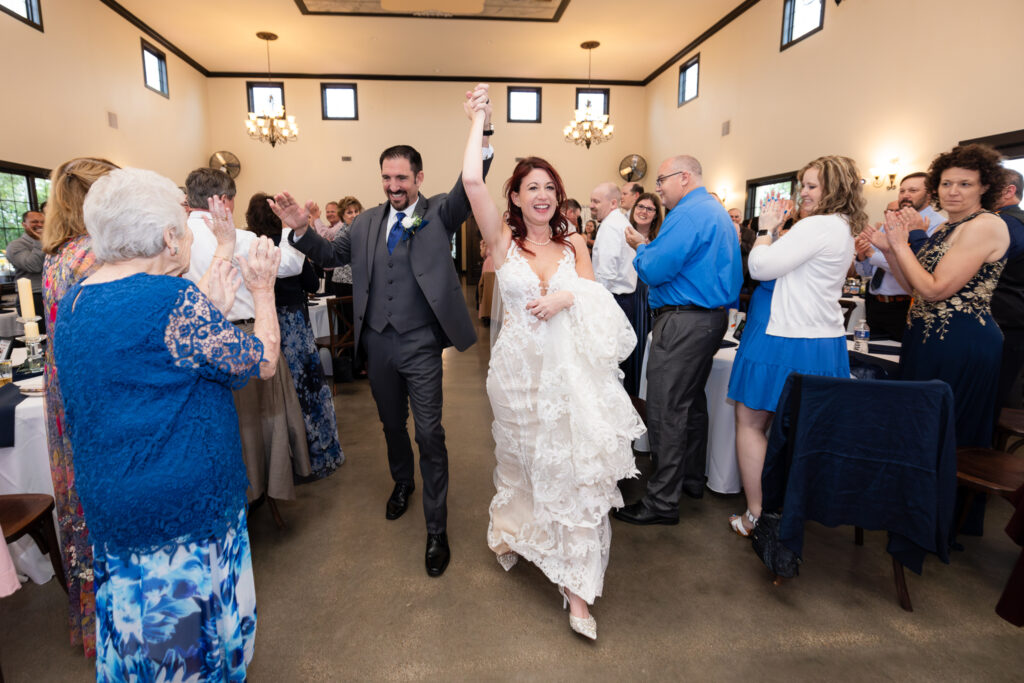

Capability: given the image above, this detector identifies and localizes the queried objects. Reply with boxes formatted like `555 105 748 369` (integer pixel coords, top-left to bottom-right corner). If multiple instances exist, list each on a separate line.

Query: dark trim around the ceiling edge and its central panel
99 0 760 86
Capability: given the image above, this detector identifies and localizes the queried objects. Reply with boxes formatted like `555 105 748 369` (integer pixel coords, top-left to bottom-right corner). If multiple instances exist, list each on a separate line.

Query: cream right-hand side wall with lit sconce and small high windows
645 0 1024 219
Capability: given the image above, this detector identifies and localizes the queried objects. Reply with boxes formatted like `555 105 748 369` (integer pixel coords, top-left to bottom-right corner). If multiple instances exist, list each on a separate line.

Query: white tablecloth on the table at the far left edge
0 349 53 584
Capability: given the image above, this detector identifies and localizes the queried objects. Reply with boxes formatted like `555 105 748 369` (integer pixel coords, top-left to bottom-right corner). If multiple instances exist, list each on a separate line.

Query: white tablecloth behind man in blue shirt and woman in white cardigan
633 331 899 494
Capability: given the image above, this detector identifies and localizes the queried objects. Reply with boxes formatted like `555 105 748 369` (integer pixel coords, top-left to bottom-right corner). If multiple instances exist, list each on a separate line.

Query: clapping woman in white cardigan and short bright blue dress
728 157 867 537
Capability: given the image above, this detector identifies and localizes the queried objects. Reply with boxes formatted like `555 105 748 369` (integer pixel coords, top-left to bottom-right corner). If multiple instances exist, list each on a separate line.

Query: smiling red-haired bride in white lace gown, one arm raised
462 85 644 639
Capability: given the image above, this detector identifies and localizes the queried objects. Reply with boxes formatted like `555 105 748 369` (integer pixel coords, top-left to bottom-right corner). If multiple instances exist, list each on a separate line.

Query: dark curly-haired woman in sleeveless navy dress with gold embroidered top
865 144 1010 447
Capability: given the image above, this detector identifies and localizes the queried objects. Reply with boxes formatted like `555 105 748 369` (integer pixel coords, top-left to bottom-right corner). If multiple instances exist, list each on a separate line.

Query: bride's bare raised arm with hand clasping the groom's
462 85 508 268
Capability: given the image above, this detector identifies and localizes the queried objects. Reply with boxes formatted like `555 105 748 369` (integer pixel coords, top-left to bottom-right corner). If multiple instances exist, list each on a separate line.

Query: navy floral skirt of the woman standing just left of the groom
278 306 345 479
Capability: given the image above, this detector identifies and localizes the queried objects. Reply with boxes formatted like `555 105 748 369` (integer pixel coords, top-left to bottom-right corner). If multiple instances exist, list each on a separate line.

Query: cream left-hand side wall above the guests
0 0 209 180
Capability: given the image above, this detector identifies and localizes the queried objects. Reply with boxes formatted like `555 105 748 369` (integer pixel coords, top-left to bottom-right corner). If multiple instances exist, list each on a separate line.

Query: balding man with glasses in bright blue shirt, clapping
612 156 743 524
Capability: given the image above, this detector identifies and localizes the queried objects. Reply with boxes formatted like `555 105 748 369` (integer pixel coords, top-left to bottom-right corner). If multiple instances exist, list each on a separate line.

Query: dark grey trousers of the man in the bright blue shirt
644 310 729 516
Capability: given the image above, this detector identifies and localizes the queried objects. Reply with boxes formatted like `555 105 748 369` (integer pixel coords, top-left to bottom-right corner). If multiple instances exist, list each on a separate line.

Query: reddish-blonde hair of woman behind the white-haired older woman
43 157 121 254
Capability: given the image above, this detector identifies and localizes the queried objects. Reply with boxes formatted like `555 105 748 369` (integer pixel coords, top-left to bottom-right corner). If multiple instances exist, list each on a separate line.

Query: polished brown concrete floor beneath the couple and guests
0 290 1024 683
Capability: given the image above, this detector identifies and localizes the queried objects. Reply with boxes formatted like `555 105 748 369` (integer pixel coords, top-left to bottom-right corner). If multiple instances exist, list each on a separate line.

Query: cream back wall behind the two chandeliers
202 79 646 224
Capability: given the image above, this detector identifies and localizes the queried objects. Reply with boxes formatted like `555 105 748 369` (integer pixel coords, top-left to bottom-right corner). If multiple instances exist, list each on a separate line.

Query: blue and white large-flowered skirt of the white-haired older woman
93 508 256 683
